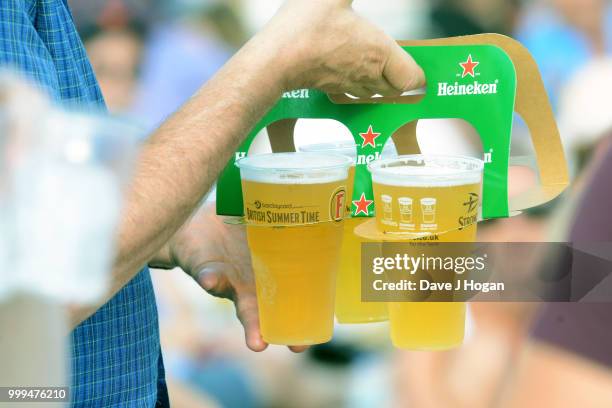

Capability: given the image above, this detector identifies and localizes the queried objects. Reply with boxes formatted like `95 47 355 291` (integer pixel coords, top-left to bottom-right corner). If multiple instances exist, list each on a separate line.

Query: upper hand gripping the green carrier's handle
258 0 425 97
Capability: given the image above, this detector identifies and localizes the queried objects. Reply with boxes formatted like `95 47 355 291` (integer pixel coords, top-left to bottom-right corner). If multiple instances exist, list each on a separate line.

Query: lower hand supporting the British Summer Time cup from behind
167 203 307 352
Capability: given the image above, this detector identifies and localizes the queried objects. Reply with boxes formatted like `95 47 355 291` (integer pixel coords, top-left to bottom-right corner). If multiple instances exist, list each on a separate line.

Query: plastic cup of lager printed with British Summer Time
237 153 351 345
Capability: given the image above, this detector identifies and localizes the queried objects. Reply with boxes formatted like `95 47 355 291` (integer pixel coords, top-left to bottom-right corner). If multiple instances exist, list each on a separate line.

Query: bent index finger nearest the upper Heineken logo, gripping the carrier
383 42 425 92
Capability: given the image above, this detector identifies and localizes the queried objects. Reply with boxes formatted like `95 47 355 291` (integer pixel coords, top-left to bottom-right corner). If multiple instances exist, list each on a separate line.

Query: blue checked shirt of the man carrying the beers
0 0 168 407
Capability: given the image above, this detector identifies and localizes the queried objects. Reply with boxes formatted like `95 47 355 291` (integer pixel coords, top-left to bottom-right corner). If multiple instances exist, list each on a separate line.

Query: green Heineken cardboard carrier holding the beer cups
217 34 569 225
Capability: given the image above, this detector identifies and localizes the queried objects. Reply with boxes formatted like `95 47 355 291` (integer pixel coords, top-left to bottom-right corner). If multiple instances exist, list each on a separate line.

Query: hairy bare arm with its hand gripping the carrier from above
73 0 424 324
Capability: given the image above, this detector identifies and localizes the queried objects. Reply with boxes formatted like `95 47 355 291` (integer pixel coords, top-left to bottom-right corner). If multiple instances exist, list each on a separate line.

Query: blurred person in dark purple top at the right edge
505 155 612 408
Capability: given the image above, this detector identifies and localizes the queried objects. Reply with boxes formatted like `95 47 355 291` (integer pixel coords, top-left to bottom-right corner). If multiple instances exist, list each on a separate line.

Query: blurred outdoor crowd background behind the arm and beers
70 0 612 408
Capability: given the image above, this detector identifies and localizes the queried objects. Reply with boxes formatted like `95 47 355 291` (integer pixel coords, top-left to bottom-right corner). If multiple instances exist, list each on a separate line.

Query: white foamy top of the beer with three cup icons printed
370 160 482 187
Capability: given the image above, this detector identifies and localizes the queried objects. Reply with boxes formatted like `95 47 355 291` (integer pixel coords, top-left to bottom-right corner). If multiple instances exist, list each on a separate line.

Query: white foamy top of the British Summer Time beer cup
236 153 351 184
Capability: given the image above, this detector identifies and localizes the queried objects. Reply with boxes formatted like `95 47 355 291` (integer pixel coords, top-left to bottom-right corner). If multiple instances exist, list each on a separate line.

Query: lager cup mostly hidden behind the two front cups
300 141 396 323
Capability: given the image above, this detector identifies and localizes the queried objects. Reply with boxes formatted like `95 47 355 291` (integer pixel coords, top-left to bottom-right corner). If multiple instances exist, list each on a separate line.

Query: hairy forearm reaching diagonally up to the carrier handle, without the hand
68 32 285 323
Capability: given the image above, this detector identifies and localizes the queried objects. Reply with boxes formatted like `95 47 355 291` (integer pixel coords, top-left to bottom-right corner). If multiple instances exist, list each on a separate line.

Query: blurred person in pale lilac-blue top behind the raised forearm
131 0 246 129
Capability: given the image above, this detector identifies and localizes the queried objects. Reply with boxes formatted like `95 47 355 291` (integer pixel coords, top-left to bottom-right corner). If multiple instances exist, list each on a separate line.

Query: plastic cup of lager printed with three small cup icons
369 155 483 350
